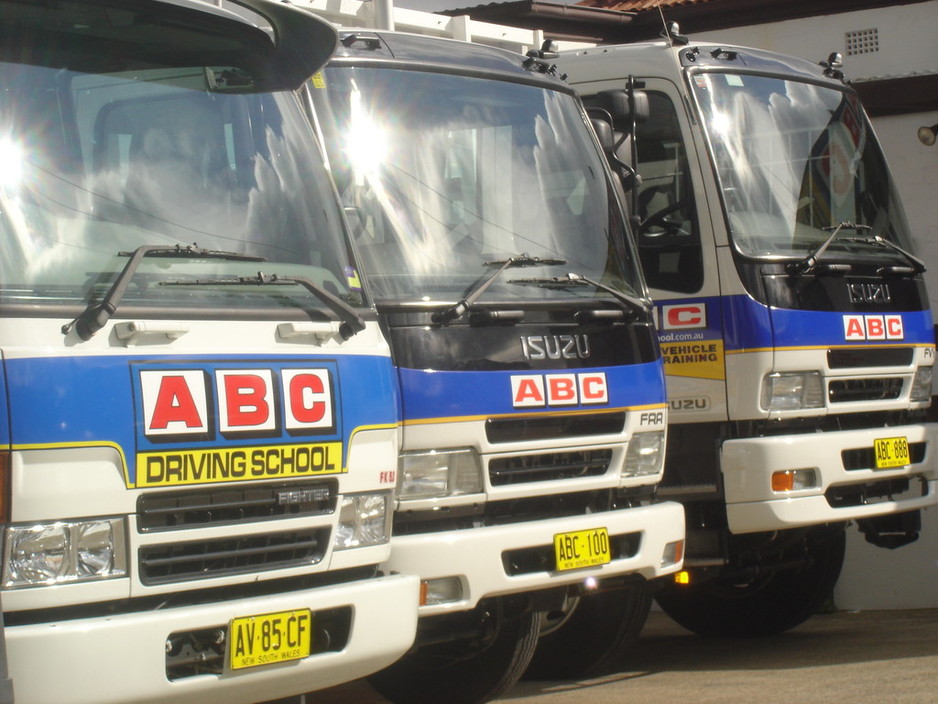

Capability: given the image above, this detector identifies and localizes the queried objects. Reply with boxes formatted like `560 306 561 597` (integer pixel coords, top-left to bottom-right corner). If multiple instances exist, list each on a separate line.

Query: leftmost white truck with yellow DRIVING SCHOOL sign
0 0 419 704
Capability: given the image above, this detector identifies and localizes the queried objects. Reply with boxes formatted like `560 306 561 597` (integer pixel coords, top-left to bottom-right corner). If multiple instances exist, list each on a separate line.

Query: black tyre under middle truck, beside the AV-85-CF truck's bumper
368 599 539 704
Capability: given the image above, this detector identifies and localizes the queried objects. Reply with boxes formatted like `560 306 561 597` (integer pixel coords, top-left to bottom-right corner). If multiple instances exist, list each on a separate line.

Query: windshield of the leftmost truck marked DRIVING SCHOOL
0 62 362 317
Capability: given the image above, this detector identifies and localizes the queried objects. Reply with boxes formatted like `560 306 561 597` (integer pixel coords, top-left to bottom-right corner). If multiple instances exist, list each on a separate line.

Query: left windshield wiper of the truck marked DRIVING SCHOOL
62 244 266 341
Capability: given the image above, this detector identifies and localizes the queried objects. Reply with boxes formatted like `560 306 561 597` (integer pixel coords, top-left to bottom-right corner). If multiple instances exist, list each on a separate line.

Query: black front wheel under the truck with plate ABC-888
656 530 846 636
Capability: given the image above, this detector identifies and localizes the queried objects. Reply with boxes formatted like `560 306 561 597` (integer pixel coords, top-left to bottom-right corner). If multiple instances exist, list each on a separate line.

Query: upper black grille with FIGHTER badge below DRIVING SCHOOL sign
137 479 338 532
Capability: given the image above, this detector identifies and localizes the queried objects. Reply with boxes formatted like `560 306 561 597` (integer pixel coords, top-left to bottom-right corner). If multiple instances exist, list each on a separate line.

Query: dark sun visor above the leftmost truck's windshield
0 0 338 92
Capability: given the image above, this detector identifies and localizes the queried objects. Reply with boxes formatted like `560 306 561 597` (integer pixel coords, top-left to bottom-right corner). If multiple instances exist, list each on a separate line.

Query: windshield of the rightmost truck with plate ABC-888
691 73 911 257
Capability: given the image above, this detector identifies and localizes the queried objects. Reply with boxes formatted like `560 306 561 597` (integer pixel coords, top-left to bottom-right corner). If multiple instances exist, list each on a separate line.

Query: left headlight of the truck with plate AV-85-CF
3 518 127 587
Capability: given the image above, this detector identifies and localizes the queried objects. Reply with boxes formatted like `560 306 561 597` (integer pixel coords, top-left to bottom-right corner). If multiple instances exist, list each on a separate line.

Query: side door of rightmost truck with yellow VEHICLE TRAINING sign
633 79 732 423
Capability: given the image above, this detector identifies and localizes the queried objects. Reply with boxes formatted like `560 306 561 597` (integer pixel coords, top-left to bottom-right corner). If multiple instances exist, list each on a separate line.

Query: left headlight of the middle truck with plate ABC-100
397 449 482 499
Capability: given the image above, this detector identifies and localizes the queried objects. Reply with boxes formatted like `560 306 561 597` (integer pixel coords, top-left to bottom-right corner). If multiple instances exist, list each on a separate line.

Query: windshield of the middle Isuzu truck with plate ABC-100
313 67 644 305
